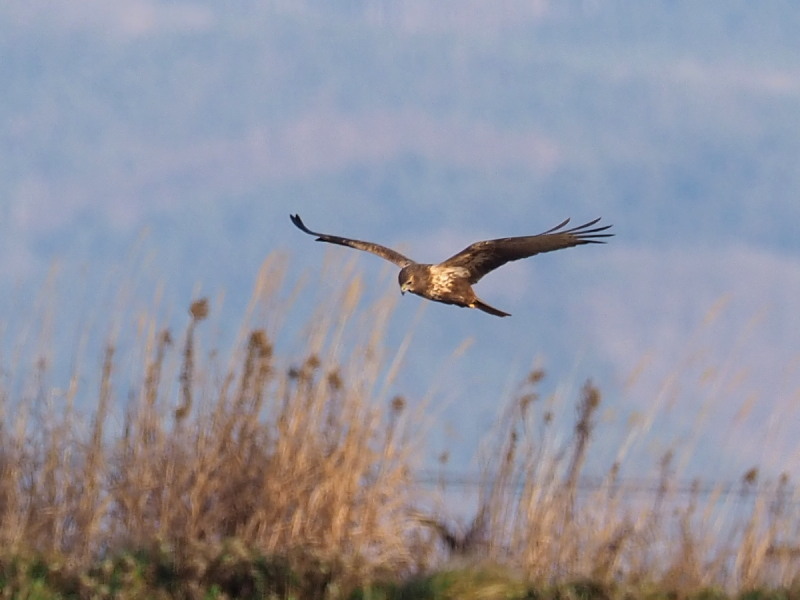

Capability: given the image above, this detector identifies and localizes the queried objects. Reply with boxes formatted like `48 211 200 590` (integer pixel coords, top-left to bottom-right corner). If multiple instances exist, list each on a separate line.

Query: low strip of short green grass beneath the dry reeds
0 556 798 600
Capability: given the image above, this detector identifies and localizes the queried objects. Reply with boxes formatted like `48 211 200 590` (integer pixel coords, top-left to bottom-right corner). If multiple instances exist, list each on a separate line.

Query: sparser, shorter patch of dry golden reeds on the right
462 370 800 594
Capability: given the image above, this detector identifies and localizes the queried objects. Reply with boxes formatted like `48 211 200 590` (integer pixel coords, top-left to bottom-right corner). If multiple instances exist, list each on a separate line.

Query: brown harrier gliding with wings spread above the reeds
289 215 614 317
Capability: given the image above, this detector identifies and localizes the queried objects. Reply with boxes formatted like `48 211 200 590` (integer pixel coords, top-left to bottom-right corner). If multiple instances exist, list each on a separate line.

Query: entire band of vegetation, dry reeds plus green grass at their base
0 263 800 600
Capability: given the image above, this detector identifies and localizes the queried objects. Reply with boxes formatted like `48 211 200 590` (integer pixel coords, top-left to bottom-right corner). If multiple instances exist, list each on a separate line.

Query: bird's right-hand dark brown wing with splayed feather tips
441 218 614 283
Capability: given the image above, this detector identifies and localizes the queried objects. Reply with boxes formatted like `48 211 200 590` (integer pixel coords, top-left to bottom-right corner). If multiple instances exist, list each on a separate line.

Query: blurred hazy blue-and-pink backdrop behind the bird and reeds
0 0 800 480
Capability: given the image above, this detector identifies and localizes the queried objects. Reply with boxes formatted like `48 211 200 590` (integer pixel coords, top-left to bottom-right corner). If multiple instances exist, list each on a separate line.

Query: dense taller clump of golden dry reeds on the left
0 254 428 592
